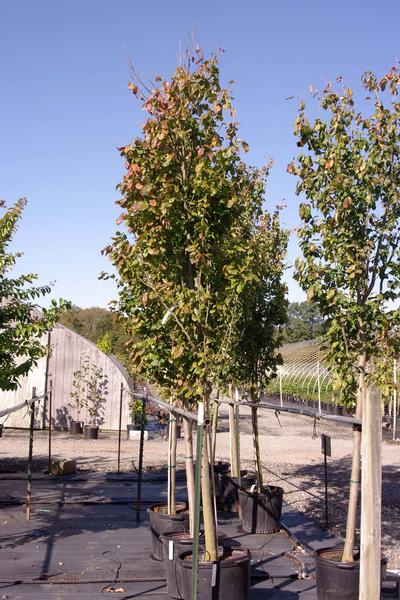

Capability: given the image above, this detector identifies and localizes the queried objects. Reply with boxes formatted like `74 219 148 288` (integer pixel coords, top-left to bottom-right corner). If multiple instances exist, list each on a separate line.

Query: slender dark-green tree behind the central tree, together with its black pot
232 210 288 533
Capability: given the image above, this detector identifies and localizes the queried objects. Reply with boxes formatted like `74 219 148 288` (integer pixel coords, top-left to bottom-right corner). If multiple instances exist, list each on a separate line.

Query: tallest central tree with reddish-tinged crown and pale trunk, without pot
106 49 272 560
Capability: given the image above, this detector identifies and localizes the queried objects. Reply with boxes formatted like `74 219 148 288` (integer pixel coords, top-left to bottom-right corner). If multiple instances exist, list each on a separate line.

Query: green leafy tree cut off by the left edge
0 198 67 390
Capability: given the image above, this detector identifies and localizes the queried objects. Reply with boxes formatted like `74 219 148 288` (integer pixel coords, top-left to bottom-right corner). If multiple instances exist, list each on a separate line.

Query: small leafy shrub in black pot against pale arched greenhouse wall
84 364 108 440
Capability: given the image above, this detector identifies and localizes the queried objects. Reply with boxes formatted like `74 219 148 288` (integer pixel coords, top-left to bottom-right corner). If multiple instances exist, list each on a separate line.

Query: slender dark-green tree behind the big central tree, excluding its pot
228 210 288 493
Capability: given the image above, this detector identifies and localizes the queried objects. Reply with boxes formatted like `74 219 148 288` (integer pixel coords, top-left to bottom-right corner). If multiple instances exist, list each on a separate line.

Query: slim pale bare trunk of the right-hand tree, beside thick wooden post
342 355 366 562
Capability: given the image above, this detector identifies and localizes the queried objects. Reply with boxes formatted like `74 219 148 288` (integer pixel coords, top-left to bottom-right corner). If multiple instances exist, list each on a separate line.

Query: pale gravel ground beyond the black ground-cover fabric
0 408 400 569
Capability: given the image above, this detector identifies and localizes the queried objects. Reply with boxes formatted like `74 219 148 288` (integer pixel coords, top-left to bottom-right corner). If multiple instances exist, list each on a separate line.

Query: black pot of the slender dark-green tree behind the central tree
239 486 283 533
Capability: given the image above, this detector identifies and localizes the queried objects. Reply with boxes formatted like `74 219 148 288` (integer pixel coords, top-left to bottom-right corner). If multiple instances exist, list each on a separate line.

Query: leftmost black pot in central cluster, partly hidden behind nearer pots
147 502 189 560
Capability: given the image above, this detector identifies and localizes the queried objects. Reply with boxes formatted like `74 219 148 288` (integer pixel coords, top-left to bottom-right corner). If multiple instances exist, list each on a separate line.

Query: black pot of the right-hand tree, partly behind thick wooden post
315 548 387 600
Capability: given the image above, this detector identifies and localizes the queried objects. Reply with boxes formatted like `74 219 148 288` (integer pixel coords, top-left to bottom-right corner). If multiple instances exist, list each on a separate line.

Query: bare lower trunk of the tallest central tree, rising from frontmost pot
202 429 218 561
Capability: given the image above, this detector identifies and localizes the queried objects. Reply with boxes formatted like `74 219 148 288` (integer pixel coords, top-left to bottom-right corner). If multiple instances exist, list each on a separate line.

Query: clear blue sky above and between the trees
0 0 400 306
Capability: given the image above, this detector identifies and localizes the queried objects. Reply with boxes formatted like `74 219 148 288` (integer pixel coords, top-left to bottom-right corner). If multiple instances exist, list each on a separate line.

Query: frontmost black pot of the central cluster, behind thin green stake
177 550 250 600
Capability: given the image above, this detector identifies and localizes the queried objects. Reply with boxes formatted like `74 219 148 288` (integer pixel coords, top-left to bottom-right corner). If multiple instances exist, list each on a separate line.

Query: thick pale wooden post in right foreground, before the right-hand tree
359 388 382 600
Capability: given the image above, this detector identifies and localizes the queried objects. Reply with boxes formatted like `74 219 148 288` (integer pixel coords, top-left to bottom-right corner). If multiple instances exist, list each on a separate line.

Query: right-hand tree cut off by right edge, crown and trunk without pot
288 68 400 562
